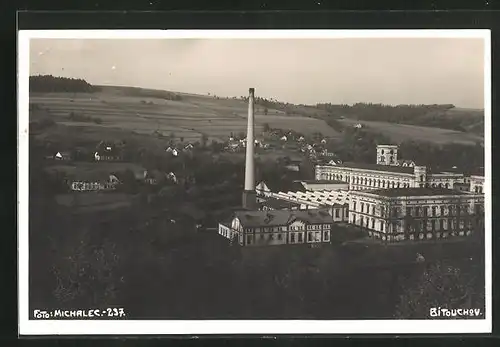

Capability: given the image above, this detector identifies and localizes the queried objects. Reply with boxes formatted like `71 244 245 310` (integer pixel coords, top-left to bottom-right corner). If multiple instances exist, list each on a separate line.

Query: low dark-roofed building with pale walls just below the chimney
219 209 333 246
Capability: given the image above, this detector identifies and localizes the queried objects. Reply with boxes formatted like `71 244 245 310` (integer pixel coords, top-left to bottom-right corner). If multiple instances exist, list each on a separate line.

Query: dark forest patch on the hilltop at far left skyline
29 75 96 93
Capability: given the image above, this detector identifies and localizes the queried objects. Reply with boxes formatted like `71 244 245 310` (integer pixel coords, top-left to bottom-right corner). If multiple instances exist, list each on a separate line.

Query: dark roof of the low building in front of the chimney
235 209 332 227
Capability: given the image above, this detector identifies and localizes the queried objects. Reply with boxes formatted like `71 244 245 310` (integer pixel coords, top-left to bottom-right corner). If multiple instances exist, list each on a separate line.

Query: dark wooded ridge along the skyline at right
316 103 484 134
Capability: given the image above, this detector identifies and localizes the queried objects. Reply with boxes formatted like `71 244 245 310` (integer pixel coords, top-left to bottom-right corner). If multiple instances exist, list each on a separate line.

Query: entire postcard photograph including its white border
18 30 492 335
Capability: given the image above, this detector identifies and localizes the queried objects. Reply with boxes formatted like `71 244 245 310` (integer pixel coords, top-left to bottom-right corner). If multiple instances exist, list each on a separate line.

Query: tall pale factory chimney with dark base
243 88 257 210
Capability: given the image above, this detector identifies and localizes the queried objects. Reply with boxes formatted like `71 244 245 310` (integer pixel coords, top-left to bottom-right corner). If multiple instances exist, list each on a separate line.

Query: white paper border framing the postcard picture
17 29 492 335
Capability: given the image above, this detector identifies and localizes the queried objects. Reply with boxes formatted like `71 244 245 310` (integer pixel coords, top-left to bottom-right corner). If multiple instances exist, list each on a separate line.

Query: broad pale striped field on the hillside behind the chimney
30 88 339 141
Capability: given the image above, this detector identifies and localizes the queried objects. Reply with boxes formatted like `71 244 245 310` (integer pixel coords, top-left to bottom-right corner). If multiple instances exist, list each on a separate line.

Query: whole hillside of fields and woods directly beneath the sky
30 76 484 144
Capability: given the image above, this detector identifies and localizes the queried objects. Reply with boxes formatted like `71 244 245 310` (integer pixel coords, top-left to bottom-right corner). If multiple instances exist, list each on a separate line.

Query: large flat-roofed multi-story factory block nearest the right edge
349 188 484 241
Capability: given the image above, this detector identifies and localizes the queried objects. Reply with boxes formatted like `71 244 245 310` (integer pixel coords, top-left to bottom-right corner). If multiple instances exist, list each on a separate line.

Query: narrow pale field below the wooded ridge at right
340 119 484 145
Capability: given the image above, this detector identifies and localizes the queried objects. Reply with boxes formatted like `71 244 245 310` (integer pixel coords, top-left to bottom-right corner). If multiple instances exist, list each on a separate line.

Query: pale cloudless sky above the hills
30 38 484 108
